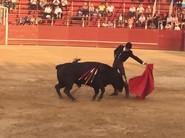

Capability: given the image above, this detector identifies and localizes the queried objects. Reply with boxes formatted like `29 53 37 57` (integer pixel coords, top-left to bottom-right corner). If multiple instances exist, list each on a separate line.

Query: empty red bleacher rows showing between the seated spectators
0 0 178 26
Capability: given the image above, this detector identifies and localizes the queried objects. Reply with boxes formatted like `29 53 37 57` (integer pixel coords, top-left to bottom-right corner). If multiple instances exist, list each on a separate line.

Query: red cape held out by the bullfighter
129 64 154 99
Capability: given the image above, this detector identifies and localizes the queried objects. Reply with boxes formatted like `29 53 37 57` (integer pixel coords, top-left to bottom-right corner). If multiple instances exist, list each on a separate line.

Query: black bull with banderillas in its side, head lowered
55 62 128 100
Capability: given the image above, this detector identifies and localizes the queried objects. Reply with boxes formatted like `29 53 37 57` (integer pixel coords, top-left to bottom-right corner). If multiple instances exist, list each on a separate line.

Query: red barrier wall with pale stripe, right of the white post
4 26 185 50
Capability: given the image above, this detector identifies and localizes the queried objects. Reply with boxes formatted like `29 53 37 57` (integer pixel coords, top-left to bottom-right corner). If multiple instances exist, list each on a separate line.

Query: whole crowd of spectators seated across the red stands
0 0 185 30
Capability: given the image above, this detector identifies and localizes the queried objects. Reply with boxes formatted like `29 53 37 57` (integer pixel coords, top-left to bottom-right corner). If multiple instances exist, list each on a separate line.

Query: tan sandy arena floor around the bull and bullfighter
0 46 185 138
